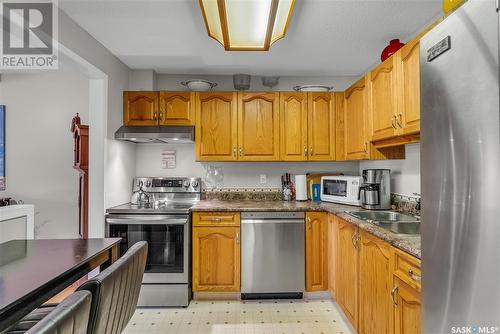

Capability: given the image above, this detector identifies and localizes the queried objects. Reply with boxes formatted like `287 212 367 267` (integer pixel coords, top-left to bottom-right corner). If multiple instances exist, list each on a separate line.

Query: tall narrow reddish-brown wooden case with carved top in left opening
71 114 89 239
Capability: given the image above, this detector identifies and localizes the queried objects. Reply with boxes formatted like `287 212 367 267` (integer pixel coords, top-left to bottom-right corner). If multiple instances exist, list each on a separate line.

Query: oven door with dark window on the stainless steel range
106 214 190 284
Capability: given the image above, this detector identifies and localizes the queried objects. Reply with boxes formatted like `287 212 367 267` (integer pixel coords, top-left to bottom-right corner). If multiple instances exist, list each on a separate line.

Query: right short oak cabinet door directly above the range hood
159 92 196 125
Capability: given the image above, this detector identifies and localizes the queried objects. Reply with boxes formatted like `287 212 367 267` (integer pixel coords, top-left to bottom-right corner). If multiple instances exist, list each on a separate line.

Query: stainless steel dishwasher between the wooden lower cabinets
241 212 305 299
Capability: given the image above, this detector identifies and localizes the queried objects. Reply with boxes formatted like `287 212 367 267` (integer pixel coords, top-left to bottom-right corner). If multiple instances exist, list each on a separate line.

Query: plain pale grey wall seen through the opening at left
0 69 89 238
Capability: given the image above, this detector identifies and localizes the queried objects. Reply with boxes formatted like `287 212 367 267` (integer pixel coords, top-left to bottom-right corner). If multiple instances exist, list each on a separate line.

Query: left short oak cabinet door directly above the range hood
123 92 159 126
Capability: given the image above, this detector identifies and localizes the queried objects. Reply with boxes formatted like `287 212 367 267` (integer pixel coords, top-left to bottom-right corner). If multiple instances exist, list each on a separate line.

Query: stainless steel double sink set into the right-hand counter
346 211 420 236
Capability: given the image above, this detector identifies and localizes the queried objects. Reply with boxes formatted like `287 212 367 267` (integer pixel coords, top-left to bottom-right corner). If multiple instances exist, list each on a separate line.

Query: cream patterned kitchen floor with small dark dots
125 299 353 334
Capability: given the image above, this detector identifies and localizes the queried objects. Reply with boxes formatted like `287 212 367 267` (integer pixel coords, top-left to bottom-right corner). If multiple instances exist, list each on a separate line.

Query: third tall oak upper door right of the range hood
280 92 308 161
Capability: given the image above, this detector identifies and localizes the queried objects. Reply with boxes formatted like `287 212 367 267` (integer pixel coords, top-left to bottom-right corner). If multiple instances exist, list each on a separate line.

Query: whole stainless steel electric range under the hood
106 177 201 307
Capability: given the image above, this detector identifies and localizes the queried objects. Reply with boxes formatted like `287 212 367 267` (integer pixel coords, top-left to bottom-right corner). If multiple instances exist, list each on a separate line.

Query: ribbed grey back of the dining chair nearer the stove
78 241 148 334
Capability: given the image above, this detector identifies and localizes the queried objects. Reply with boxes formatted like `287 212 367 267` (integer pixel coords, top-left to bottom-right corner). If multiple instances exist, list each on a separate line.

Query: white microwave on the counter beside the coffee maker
321 175 363 206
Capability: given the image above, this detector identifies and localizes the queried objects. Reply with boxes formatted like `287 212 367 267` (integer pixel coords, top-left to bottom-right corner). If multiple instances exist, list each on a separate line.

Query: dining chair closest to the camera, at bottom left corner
4 290 92 334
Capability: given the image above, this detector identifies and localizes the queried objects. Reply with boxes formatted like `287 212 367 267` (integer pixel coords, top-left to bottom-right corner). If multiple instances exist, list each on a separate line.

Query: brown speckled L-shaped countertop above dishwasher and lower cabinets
191 200 421 259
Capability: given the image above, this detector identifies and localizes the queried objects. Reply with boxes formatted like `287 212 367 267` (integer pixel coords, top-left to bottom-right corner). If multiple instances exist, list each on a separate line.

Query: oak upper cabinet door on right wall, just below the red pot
368 57 400 141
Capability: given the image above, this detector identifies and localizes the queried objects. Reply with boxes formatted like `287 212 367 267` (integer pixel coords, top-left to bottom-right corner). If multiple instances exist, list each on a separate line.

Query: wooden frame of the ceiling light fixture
198 0 295 51
